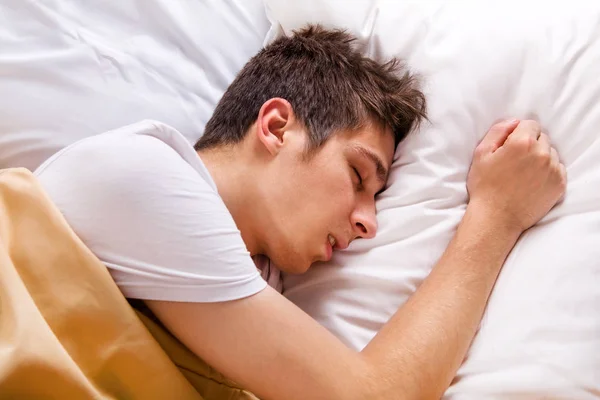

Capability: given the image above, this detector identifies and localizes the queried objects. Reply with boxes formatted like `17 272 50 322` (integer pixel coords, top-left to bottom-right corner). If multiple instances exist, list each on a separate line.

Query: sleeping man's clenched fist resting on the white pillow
467 120 567 232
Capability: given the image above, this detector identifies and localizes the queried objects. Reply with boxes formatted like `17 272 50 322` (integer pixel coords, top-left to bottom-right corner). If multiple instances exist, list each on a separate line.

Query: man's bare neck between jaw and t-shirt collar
198 146 264 255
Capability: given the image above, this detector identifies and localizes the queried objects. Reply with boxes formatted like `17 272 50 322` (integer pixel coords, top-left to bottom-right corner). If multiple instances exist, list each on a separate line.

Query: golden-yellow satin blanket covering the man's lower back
0 169 256 400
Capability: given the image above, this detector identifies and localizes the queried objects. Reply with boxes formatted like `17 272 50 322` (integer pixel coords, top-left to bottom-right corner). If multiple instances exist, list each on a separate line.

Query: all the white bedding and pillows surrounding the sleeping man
0 0 600 399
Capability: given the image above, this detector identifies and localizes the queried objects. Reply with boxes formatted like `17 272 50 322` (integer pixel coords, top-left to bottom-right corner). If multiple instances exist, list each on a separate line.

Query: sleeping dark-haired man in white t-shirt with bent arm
36 26 566 400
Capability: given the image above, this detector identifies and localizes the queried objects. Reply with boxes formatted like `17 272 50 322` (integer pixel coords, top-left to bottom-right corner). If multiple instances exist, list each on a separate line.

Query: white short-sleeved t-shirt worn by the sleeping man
36 121 266 302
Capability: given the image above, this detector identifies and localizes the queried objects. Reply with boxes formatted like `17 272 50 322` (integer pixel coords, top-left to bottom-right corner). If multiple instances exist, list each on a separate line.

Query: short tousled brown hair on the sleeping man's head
195 25 425 151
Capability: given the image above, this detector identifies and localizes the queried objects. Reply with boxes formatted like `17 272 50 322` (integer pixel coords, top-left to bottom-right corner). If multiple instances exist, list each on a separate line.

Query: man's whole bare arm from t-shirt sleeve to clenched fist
148 122 565 400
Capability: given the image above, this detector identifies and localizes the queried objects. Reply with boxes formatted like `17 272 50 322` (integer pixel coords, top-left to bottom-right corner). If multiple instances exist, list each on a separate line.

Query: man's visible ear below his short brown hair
256 97 294 155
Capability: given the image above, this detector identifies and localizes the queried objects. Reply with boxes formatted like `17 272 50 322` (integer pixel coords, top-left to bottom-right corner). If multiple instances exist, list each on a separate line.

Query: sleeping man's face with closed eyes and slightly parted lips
264 125 394 273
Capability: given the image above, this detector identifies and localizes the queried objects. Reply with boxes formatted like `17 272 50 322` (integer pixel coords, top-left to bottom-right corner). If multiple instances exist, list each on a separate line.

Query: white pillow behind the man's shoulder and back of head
0 0 269 169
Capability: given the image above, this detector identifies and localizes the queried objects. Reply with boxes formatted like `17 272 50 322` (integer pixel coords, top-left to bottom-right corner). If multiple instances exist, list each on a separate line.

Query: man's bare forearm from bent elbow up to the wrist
363 206 520 399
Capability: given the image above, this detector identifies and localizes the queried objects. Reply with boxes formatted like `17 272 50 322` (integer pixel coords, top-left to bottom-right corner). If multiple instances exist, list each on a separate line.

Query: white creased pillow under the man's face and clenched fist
267 0 600 399
